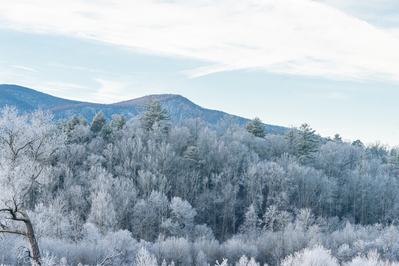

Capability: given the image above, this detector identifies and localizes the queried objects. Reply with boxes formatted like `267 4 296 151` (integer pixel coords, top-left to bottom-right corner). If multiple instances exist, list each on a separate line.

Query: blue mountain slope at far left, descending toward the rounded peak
0 84 81 113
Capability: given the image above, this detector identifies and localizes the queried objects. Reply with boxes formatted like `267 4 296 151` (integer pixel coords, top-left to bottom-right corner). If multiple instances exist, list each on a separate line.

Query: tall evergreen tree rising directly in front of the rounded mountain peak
138 96 170 131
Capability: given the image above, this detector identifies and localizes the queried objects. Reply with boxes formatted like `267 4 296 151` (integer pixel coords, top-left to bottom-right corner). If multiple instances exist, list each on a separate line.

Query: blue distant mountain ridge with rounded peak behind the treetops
0 84 287 133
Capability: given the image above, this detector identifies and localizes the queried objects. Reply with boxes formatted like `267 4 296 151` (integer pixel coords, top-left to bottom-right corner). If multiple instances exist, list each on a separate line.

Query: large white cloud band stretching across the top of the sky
0 0 399 80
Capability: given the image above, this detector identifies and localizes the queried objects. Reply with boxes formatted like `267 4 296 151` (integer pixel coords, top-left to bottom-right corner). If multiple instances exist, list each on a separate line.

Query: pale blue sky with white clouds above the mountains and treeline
0 0 399 146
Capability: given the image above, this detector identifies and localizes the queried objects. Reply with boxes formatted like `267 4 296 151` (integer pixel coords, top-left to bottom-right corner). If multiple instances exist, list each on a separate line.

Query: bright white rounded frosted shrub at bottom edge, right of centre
281 246 339 266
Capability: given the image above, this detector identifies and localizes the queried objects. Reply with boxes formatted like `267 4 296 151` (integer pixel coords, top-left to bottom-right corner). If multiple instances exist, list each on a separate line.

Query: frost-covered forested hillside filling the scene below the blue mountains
0 98 399 266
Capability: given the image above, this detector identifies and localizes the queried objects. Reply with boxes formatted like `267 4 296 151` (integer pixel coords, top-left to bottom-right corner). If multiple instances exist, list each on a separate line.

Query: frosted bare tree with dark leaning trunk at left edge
0 107 65 265
